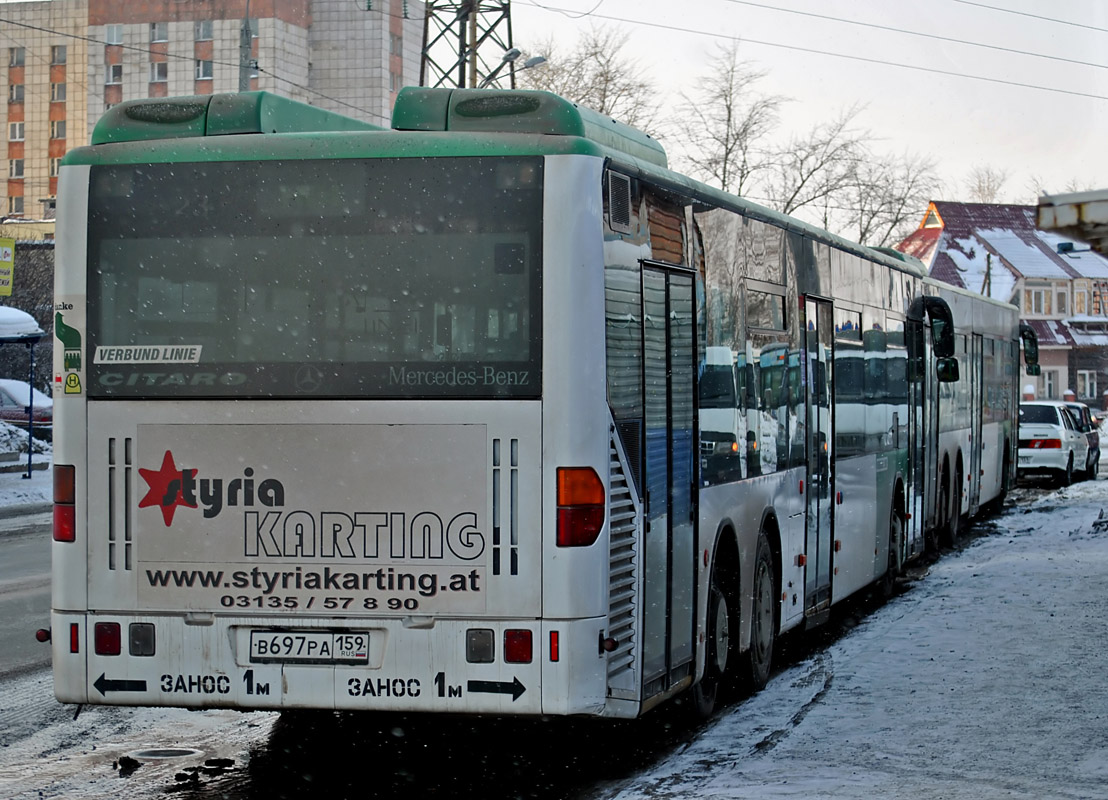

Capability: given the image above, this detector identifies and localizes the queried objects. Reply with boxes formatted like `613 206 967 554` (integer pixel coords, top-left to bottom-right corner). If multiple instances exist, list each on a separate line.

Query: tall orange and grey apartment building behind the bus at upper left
0 0 423 218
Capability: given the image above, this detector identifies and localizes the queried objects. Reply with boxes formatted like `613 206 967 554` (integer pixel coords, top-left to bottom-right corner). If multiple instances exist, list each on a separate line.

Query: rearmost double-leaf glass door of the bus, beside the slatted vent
643 265 698 696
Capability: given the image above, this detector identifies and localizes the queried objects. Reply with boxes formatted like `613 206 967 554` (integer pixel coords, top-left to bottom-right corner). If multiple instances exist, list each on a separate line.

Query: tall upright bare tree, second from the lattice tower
675 41 784 195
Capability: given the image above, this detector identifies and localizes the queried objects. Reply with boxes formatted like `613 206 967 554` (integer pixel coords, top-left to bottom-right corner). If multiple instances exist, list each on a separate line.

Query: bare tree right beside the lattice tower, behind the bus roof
515 27 658 130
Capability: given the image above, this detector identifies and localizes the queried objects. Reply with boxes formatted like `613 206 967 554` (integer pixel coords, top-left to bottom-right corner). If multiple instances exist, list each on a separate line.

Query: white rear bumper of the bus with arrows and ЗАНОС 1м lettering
52 613 606 715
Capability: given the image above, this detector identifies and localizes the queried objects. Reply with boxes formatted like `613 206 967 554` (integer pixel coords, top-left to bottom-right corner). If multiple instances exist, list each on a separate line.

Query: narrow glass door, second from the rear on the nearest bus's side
804 299 834 620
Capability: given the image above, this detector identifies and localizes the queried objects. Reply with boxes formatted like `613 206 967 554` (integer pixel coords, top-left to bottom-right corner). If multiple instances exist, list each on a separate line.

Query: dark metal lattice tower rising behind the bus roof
419 0 515 89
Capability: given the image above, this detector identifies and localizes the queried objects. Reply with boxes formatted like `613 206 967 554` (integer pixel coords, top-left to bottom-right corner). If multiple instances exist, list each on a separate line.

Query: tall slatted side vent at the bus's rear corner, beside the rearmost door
607 431 639 686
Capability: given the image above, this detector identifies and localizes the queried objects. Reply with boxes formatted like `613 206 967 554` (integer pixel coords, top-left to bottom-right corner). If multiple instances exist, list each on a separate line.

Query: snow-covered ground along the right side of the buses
603 480 1108 800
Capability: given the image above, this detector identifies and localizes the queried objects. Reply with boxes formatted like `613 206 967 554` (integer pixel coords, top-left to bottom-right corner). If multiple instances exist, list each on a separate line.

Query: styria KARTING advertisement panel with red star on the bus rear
132 424 489 616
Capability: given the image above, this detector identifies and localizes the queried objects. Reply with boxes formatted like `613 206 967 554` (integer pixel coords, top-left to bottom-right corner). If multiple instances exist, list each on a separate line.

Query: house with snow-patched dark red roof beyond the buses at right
896 201 1108 408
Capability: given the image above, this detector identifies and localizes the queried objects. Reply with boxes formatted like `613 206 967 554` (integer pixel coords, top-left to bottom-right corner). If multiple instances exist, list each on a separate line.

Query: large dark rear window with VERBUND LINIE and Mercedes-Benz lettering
88 158 542 398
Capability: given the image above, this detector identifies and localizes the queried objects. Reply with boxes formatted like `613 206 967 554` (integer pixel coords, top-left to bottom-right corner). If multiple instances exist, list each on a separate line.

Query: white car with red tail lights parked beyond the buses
1016 400 1089 486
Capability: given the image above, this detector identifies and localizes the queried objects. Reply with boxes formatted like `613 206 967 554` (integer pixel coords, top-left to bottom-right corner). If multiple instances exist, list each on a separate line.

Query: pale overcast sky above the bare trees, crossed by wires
512 0 1108 203
